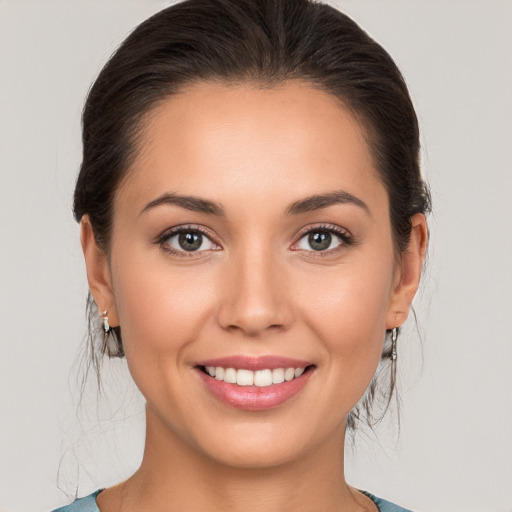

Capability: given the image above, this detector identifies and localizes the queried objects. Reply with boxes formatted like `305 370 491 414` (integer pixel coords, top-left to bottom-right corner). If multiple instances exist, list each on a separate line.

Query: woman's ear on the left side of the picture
80 215 119 327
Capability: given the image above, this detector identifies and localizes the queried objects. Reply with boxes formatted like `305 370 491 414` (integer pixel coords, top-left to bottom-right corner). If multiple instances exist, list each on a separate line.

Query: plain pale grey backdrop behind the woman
0 0 512 512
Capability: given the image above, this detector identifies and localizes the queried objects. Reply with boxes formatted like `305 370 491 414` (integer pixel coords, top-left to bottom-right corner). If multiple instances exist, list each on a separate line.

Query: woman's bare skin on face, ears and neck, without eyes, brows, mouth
81 81 427 512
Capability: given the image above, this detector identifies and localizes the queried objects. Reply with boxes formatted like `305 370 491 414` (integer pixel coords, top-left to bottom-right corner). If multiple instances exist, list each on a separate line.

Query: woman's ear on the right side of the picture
386 213 428 329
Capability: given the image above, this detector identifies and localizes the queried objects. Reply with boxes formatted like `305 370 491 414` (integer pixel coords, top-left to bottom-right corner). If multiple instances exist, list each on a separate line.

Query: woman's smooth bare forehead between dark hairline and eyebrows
120 81 387 214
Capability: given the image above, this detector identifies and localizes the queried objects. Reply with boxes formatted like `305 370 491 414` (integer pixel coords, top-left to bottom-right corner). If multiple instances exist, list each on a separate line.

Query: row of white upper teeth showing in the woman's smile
203 366 306 387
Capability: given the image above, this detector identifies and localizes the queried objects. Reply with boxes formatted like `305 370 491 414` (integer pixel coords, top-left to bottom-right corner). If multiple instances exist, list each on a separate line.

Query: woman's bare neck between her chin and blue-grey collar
98 404 364 512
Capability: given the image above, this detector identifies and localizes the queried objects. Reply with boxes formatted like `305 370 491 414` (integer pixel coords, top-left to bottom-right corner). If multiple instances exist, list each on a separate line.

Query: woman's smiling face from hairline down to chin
83 82 417 467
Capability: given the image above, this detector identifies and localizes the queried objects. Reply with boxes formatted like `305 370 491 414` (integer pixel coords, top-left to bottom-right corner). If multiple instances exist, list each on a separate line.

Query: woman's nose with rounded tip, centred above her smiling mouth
217 246 293 337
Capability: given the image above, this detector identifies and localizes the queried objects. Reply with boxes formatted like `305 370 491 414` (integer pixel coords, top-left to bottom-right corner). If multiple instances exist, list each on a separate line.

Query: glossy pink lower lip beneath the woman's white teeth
197 368 313 411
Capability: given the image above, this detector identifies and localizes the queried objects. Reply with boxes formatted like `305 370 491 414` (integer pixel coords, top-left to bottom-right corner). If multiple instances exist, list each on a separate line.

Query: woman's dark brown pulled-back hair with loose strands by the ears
74 0 430 427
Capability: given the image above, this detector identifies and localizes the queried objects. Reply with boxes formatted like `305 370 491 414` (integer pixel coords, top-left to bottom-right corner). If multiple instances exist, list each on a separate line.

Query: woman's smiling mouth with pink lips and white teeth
195 357 316 411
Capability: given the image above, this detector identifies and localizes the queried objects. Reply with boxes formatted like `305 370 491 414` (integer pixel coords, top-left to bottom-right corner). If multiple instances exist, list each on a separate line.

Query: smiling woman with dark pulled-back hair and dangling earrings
54 0 429 512
